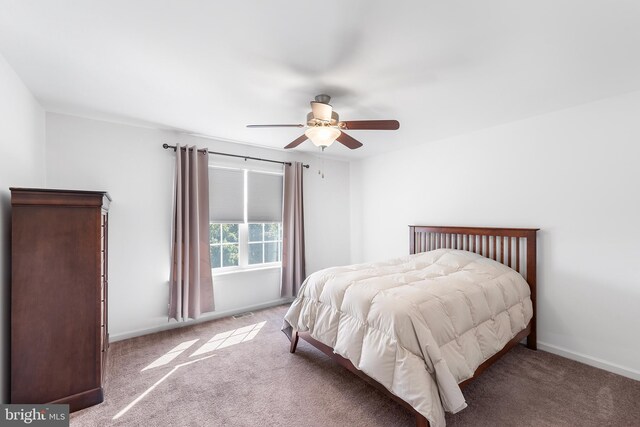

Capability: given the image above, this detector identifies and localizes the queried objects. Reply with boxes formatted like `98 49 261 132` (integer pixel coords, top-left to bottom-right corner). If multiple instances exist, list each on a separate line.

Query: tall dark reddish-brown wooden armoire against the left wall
11 188 111 411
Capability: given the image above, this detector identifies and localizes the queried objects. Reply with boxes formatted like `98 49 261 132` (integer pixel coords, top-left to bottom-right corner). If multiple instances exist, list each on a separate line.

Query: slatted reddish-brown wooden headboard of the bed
409 225 539 350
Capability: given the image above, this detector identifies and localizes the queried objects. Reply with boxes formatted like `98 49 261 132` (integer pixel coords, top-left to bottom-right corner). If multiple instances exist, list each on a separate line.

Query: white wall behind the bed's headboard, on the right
351 92 640 379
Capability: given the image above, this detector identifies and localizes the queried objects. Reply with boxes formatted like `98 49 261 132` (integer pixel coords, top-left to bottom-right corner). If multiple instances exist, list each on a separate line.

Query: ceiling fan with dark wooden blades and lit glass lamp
247 94 400 150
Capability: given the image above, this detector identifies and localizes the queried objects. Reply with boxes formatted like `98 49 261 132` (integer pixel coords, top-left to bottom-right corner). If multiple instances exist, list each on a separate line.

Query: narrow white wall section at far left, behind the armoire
0 55 45 403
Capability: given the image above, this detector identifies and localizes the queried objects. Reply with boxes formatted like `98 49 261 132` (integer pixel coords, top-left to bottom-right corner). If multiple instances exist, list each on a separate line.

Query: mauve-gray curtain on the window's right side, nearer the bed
280 162 306 297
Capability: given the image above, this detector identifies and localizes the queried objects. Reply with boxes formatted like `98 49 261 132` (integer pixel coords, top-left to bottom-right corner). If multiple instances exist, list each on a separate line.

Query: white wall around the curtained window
46 113 350 340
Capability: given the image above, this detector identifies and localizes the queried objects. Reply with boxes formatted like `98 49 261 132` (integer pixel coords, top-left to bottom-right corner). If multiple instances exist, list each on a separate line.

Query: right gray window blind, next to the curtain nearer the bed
247 171 282 223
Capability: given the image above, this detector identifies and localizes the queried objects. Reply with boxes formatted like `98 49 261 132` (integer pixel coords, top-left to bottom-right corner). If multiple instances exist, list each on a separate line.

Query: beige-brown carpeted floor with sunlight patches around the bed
71 306 640 427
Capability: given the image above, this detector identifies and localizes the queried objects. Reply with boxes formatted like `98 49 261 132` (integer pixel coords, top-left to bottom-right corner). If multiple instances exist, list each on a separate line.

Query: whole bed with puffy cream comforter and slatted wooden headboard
283 226 537 427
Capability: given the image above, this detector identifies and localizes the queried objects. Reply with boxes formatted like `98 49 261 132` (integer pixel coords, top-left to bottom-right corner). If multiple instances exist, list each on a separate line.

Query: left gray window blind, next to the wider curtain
209 167 244 223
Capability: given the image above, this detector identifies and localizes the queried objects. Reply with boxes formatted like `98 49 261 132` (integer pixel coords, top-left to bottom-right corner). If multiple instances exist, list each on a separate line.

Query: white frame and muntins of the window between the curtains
209 164 284 276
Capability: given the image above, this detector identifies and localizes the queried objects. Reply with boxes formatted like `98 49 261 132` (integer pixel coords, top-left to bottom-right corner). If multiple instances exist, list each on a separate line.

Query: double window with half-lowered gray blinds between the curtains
209 166 283 269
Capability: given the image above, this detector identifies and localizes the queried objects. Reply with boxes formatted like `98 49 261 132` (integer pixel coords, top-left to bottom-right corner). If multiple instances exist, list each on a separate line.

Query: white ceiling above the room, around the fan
0 0 640 158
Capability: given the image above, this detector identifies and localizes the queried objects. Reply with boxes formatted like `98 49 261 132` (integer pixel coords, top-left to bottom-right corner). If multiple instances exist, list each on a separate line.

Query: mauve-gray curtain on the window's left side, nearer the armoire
169 144 214 321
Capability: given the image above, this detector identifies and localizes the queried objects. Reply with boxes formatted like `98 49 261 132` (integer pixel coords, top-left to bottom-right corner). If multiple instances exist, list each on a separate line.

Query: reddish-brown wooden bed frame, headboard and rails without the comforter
285 225 538 427
